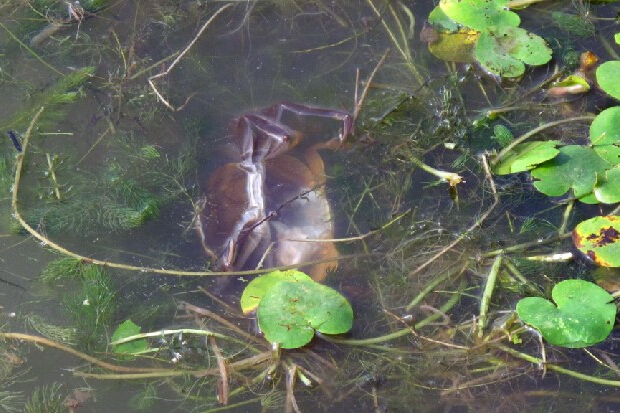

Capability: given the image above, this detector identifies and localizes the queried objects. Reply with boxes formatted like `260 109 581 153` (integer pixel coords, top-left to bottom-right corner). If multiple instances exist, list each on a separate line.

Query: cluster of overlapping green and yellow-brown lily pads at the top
428 0 552 78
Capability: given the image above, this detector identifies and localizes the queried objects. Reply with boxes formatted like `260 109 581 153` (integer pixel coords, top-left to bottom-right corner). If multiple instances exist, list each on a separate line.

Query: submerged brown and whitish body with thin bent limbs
197 103 353 281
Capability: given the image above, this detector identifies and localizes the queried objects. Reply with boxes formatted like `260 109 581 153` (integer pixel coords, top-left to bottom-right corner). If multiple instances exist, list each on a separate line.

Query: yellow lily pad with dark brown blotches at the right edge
573 215 620 267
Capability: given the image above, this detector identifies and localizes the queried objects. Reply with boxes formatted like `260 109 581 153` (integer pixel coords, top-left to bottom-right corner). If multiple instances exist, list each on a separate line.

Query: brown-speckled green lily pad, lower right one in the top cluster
475 26 552 78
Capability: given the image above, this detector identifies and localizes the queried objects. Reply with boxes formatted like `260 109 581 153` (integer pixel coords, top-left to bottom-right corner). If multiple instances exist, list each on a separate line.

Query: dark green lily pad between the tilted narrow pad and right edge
531 145 610 198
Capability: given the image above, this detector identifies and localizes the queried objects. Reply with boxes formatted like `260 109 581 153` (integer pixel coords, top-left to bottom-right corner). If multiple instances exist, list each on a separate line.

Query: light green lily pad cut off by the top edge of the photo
439 0 521 30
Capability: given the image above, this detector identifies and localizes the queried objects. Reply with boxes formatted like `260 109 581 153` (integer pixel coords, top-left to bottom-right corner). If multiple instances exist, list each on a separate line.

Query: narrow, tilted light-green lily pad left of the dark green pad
494 141 561 175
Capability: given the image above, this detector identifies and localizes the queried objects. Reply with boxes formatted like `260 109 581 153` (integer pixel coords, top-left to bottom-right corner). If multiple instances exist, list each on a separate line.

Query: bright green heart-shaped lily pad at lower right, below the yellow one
517 280 616 348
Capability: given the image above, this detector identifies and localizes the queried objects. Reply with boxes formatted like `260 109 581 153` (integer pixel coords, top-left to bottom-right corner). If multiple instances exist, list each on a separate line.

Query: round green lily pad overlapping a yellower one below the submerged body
256 280 353 348
